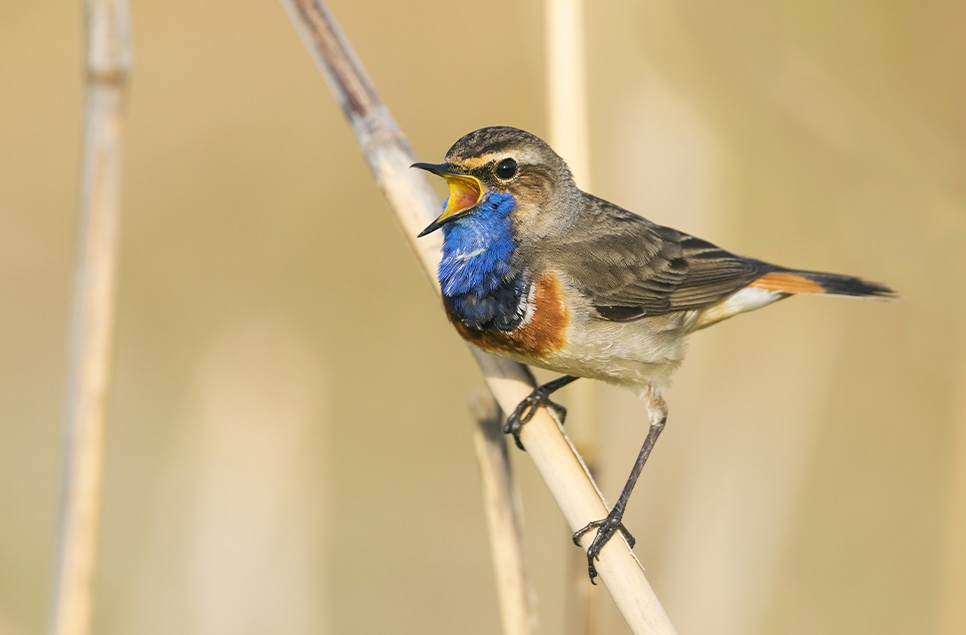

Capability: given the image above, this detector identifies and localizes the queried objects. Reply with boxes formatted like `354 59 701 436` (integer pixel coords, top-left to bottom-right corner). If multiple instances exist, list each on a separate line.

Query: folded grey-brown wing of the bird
558 198 774 322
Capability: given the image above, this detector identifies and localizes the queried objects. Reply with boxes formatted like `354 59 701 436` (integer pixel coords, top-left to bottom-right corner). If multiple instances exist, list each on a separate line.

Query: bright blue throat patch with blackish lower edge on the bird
438 193 529 331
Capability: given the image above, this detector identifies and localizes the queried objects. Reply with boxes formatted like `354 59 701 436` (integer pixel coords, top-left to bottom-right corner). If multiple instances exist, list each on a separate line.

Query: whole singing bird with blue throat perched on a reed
412 126 895 583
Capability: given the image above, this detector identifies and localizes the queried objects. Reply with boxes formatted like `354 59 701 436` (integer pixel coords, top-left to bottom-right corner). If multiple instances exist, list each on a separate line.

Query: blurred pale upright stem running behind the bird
543 0 600 635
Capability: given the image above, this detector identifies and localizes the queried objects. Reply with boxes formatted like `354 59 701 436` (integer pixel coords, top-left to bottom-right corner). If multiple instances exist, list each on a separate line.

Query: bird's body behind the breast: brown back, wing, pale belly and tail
506 194 891 388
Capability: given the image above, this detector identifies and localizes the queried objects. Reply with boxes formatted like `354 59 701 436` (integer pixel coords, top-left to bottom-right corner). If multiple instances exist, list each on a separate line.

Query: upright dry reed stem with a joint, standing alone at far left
49 0 132 635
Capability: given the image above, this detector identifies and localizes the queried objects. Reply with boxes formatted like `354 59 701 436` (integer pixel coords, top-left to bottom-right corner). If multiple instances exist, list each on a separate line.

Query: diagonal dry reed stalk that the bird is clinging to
280 0 675 634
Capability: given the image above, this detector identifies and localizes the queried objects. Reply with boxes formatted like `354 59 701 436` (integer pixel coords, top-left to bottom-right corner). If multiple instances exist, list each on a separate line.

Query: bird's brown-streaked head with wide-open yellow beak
412 126 579 236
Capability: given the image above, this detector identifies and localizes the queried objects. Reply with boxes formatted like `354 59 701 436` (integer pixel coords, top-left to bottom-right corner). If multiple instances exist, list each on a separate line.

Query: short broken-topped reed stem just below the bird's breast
470 389 536 635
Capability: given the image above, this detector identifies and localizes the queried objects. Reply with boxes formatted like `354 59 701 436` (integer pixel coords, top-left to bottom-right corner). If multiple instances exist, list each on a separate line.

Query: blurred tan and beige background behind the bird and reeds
0 0 966 635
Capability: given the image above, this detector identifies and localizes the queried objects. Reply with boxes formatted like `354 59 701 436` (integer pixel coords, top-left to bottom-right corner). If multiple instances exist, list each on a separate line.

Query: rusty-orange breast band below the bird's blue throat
444 273 571 361
